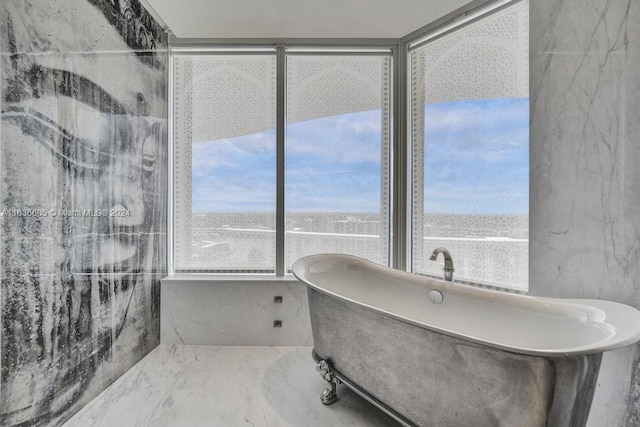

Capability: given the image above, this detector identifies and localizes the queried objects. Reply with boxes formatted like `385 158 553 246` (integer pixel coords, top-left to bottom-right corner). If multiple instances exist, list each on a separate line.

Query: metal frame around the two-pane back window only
167 39 399 279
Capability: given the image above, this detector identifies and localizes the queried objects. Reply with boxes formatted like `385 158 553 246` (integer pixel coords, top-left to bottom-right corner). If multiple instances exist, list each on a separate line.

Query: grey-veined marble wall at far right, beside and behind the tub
530 0 640 426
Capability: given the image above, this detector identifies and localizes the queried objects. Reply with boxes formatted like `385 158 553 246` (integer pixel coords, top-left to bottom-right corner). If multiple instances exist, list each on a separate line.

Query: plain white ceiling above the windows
143 0 471 38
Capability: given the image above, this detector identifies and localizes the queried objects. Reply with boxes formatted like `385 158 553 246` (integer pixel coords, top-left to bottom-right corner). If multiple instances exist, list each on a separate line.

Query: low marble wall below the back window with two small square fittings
160 277 313 346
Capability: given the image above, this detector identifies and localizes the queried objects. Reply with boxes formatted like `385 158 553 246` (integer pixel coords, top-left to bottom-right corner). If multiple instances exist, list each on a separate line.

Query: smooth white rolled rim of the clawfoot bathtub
291 253 640 358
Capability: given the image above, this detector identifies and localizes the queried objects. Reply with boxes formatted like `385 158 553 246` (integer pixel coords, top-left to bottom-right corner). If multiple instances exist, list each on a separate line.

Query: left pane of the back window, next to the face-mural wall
174 55 276 271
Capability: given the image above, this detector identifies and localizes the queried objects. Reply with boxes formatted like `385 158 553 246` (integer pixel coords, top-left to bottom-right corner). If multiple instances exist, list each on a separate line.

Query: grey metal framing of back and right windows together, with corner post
167 0 526 292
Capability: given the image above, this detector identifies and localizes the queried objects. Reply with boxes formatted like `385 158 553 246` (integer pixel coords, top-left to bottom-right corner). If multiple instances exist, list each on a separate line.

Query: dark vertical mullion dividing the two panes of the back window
276 44 286 276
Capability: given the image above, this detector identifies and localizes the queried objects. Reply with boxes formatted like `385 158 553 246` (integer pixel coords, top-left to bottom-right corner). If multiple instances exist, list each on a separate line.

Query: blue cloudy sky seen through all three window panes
192 99 529 214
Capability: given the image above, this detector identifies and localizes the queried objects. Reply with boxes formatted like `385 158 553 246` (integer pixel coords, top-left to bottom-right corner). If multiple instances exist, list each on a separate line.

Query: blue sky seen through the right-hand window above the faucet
424 98 529 214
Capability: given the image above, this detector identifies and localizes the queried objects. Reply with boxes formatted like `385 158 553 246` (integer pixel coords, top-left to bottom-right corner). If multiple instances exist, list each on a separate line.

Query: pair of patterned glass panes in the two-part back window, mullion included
173 49 391 273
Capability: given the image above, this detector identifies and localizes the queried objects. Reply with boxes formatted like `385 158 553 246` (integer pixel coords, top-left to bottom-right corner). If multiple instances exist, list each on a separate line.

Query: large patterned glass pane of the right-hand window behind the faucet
411 1 529 290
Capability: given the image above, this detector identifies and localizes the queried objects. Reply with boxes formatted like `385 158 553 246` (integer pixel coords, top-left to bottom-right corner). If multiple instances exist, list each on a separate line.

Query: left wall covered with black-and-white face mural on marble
0 0 167 426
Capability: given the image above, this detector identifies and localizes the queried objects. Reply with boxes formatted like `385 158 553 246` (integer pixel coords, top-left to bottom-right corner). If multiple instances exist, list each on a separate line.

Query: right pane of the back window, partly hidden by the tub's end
285 55 390 269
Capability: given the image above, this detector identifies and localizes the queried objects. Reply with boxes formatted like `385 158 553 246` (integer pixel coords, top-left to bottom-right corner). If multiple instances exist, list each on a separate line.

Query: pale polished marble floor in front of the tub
64 344 399 427
